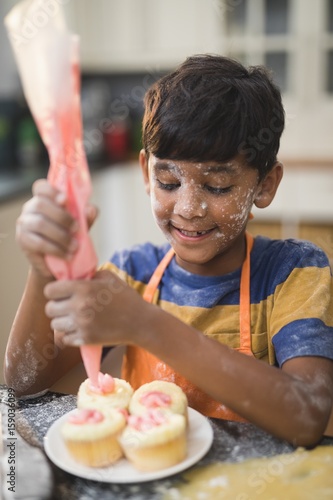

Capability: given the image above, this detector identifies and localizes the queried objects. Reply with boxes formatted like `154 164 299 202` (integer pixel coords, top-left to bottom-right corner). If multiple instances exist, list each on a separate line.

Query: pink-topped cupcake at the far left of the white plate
61 409 126 467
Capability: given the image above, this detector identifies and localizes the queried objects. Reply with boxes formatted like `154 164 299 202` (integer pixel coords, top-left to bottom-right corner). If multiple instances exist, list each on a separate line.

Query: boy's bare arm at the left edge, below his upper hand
4 268 81 397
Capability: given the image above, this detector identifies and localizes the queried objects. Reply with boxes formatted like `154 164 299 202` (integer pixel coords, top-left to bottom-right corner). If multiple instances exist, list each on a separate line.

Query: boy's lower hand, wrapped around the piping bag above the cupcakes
44 271 146 345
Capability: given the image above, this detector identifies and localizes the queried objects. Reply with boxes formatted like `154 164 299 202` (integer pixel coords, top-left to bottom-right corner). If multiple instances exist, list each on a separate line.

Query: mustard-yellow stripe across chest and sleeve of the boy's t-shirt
100 263 333 364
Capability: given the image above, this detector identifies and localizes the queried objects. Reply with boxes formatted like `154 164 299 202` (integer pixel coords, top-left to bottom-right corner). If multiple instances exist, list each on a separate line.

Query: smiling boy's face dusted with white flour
141 154 268 275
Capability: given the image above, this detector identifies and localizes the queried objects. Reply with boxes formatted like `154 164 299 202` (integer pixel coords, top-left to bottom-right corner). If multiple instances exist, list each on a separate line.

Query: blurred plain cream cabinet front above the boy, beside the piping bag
65 0 219 72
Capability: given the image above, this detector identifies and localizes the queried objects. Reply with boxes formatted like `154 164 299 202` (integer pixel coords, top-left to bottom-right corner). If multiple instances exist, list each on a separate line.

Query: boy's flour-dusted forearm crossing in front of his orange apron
137 306 330 445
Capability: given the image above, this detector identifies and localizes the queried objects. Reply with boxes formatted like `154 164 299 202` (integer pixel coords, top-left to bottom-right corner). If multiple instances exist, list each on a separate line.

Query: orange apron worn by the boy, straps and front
122 233 253 422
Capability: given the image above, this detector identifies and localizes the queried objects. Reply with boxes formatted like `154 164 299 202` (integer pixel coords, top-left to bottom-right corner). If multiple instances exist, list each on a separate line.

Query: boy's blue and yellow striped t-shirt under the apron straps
102 236 333 366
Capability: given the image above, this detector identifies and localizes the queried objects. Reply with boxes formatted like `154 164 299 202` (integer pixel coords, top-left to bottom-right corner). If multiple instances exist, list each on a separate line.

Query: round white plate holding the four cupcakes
44 408 213 483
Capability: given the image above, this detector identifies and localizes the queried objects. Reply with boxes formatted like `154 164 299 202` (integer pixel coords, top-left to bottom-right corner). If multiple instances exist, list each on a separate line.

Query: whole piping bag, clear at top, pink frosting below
4 0 102 387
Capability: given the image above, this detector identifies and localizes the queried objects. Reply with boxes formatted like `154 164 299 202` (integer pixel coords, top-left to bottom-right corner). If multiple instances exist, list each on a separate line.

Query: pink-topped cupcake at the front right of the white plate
119 409 187 472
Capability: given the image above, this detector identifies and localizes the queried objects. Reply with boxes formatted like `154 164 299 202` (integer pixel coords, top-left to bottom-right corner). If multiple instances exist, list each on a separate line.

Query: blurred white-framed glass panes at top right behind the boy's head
219 0 333 98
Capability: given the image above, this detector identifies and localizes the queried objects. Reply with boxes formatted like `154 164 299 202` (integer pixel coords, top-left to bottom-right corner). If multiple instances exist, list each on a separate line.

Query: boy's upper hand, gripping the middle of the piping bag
16 179 97 278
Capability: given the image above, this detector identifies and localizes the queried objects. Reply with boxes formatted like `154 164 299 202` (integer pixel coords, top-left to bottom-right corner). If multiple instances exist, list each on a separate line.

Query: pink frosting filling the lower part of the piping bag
47 45 102 387
